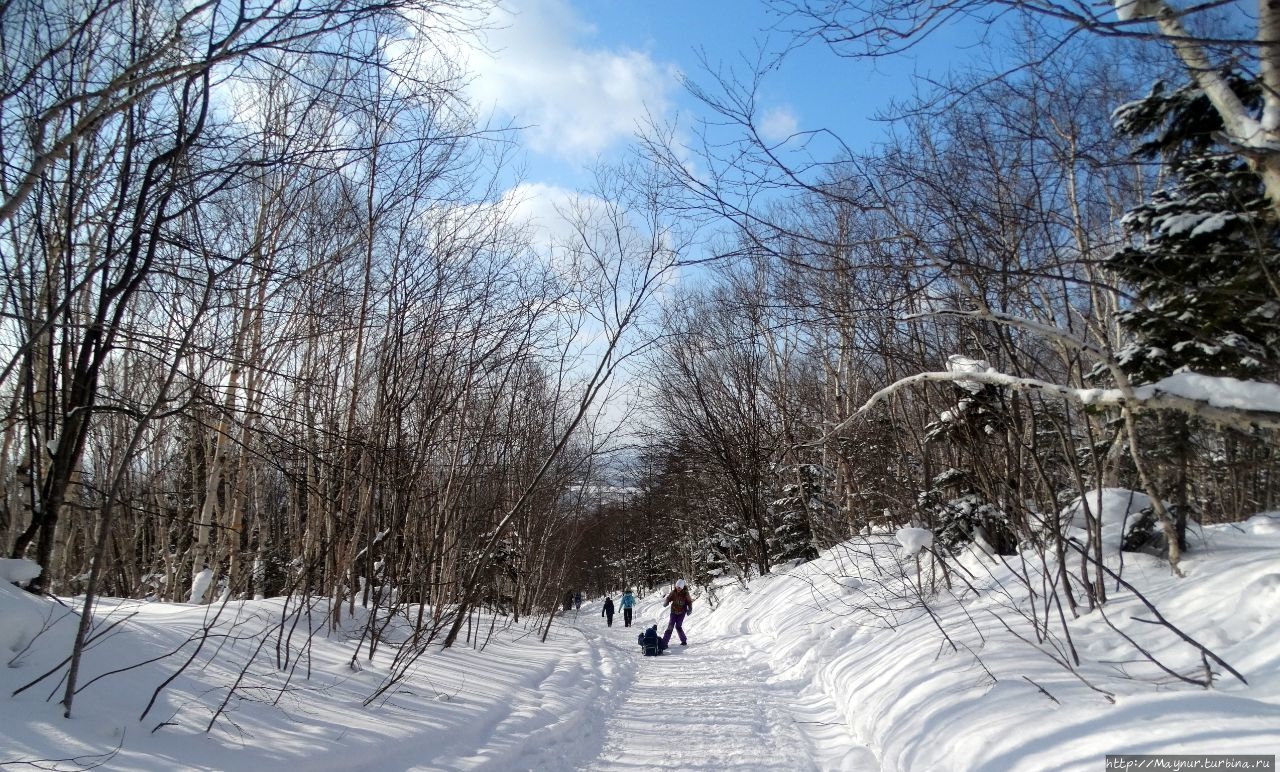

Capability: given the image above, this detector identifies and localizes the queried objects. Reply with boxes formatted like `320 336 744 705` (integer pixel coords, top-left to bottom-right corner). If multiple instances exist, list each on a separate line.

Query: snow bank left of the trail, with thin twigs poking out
0 583 588 772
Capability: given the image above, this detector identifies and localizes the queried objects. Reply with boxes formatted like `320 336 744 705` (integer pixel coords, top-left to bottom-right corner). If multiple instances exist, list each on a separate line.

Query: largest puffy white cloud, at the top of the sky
468 0 677 157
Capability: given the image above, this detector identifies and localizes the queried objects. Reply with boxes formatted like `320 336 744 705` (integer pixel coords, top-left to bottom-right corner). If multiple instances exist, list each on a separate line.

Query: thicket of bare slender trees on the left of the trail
0 0 680 708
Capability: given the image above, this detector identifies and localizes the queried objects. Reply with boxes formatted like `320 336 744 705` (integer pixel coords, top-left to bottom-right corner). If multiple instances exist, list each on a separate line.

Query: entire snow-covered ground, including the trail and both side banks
0 515 1280 772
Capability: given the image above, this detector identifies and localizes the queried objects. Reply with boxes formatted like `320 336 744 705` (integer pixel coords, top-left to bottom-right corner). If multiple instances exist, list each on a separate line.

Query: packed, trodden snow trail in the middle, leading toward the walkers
509 613 877 772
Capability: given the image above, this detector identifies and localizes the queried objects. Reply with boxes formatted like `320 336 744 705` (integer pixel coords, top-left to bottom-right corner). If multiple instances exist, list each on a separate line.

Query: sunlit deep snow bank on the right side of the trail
704 522 1280 772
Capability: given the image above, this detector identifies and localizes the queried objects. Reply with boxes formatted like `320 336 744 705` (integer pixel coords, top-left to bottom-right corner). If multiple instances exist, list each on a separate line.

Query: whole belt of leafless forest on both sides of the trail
0 0 1280 686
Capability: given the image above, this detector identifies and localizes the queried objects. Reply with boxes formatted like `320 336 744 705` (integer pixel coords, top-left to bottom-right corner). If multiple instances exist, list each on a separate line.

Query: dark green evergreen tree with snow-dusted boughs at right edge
1108 73 1280 382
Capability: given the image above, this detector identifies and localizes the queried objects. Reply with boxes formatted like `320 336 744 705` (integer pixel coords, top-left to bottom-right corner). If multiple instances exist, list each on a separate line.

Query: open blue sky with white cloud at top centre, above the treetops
460 0 988 189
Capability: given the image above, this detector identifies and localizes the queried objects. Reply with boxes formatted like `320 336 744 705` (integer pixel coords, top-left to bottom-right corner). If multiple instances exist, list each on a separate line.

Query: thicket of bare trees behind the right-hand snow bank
629 28 1280 603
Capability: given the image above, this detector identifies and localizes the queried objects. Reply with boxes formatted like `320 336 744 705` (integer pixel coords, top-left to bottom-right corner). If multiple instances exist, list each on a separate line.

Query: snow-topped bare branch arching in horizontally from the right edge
833 367 1280 431
